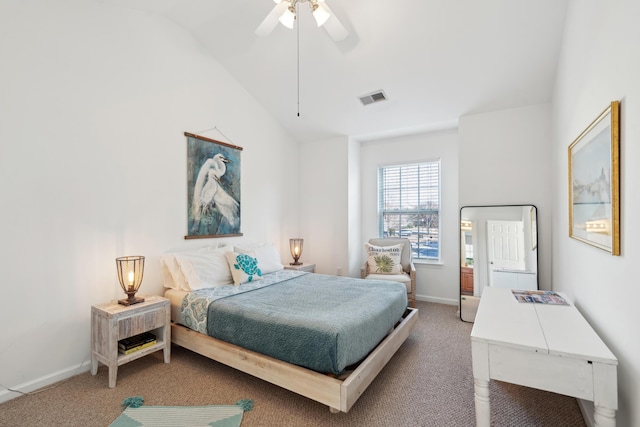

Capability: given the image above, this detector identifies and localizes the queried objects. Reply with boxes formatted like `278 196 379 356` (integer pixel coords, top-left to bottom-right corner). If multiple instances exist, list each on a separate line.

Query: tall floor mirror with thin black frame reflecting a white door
460 205 538 322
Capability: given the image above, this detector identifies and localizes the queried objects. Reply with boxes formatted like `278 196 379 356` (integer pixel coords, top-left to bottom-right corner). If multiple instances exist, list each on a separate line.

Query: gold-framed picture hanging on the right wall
569 101 620 255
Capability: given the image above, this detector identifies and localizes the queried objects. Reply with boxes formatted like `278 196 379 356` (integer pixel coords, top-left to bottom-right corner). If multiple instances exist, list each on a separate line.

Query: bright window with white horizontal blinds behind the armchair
378 160 440 260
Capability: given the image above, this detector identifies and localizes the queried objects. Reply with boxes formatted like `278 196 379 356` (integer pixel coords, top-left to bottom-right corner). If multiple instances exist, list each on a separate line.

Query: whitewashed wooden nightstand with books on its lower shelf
91 295 171 388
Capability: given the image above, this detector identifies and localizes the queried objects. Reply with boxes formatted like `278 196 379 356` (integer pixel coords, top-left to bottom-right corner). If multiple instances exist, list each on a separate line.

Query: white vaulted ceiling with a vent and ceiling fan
97 0 568 141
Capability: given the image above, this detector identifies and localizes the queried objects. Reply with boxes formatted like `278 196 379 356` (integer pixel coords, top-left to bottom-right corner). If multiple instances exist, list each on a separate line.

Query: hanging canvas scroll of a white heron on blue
184 132 242 239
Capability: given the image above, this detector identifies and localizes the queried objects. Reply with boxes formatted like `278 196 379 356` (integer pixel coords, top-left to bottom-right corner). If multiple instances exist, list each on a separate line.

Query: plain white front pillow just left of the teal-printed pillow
175 246 233 291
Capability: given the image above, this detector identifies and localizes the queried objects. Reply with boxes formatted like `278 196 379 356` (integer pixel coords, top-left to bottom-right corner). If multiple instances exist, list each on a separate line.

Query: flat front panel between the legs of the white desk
489 344 594 401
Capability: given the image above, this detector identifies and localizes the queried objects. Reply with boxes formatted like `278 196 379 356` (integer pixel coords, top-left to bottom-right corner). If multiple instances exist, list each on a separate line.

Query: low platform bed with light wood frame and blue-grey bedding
163 247 418 412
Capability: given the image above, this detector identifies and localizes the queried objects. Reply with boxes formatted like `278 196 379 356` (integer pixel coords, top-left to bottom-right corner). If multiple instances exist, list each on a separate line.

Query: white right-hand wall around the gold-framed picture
553 0 640 426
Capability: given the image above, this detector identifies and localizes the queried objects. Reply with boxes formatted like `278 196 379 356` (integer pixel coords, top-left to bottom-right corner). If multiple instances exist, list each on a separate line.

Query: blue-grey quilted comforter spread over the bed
198 274 407 374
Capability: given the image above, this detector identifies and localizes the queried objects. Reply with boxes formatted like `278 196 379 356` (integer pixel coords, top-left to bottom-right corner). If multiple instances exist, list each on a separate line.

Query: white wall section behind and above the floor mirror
458 104 552 289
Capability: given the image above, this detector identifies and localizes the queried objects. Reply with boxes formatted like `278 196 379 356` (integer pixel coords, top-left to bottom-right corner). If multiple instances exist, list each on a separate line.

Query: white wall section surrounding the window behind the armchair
360 129 460 304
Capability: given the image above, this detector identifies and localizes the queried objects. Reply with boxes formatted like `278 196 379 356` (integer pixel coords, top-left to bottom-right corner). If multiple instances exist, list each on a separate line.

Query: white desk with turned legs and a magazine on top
471 287 618 427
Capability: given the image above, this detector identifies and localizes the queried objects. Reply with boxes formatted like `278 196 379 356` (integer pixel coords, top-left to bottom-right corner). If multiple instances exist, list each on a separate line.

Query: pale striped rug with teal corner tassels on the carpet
109 398 252 427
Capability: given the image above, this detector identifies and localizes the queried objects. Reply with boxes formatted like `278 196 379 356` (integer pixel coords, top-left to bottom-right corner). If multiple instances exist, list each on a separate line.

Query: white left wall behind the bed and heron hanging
0 0 299 401
